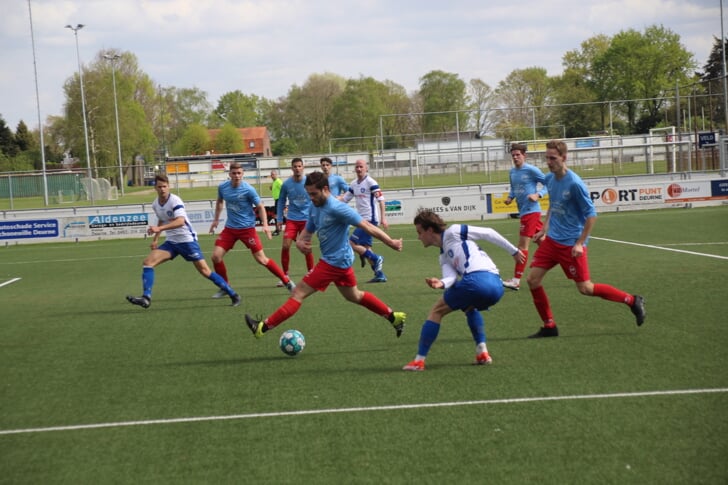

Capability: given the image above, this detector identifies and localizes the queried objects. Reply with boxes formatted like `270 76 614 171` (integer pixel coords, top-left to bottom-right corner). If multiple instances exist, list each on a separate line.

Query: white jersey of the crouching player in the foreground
440 224 518 288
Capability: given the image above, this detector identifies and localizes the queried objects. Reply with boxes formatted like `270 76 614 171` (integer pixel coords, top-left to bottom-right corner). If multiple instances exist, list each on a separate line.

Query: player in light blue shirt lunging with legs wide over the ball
245 172 407 338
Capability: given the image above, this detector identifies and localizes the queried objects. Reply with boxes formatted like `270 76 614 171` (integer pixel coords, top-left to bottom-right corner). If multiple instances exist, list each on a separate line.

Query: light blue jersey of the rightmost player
546 170 597 246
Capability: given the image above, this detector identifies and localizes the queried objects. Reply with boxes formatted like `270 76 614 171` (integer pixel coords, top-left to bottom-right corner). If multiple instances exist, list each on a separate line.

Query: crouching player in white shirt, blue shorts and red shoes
403 209 524 371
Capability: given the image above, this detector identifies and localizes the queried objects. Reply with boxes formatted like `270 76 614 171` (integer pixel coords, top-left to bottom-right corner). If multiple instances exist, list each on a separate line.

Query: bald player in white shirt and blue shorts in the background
342 160 389 283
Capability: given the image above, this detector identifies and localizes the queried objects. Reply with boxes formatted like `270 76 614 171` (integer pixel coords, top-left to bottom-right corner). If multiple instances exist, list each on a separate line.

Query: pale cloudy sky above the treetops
0 0 728 130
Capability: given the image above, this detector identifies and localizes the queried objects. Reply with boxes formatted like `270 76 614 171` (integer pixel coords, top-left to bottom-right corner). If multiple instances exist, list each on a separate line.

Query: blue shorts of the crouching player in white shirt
443 271 505 311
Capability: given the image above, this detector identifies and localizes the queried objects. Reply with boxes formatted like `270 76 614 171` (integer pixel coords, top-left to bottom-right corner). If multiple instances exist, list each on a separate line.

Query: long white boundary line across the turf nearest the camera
0 387 728 435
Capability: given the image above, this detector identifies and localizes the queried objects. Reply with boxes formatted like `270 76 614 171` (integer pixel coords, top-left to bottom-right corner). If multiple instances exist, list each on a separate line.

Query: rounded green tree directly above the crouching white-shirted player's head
419 70 467 134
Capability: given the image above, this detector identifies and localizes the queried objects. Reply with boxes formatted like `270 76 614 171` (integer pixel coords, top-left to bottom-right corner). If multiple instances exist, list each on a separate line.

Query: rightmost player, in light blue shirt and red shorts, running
526 140 646 338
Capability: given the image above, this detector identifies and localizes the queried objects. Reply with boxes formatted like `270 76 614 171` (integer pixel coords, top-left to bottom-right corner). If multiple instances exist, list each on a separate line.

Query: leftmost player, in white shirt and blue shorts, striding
126 174 240 308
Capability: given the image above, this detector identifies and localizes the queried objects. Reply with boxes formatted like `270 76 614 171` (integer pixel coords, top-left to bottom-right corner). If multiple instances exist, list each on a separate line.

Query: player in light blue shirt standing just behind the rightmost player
503 143 547 290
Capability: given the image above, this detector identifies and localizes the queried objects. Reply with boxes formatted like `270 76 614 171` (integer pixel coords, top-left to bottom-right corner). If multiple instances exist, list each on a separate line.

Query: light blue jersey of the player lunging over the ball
306 195 362 268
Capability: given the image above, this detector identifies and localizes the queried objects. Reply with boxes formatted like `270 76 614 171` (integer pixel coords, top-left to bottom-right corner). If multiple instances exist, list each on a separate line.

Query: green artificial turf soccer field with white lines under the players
0 207 728 484
